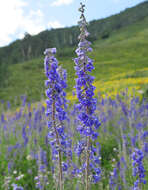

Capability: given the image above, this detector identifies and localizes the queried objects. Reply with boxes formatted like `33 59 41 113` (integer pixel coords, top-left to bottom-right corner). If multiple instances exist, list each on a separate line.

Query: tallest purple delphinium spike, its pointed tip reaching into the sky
74 3 101 190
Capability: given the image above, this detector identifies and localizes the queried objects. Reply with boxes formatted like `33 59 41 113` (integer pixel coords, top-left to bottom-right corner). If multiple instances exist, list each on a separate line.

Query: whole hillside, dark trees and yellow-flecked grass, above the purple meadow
0 2 148 104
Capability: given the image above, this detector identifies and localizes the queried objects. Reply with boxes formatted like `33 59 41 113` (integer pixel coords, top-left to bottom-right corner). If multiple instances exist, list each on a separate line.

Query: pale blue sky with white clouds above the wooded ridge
0 0 144 47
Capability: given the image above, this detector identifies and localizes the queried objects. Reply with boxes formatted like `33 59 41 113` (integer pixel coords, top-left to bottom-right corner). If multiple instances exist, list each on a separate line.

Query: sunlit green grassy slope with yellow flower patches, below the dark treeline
0 17 148 104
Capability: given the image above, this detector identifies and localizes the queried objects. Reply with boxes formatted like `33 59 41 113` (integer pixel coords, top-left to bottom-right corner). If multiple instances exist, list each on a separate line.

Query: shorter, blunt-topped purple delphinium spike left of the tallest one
44 48 70 190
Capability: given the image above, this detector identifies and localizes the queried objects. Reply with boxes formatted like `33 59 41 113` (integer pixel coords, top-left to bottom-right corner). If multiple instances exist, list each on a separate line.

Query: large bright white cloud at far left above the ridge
0 0 45 46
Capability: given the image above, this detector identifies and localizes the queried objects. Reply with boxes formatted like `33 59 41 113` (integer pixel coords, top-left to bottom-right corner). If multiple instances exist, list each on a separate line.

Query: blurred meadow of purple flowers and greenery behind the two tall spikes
0 92 148 190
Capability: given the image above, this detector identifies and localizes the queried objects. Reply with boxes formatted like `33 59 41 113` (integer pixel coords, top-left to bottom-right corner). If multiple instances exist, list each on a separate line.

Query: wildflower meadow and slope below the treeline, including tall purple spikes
0 3 148 190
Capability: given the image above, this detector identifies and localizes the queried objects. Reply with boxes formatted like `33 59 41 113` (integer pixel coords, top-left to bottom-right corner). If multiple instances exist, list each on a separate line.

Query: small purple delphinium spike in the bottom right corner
132 148 146 190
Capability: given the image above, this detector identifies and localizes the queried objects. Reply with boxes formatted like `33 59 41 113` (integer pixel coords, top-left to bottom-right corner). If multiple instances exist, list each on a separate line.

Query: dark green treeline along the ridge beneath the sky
0 2 148 86
